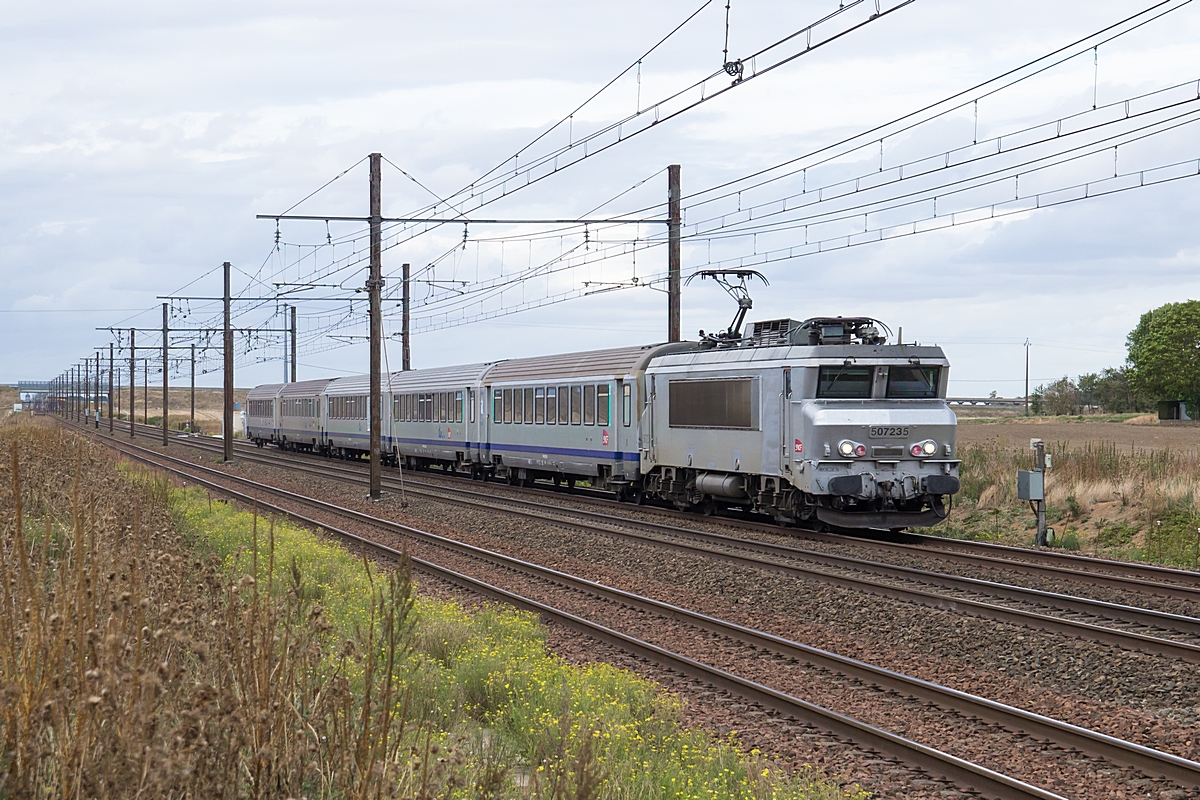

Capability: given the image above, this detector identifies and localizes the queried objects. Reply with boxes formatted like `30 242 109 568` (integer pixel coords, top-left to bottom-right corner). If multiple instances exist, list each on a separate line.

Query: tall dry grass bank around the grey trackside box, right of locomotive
934 443 1200 567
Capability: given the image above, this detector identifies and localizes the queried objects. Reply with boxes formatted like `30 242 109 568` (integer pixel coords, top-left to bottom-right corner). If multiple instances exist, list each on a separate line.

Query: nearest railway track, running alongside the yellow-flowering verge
72 422 1200 800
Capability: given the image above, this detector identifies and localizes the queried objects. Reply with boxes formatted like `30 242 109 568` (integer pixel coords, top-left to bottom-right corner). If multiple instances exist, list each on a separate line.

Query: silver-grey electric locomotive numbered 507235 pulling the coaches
638 317 960 528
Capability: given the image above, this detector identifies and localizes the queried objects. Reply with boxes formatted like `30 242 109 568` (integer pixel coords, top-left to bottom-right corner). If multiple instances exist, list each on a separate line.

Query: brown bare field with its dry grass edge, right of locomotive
935 416 1200 566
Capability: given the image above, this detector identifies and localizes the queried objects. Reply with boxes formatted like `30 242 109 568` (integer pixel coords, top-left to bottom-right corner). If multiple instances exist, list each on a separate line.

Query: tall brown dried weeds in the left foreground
0 427 444 798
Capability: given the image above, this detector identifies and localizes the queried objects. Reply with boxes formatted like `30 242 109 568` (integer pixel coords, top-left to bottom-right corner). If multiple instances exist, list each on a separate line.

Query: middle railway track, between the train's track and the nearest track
103 424 1200 663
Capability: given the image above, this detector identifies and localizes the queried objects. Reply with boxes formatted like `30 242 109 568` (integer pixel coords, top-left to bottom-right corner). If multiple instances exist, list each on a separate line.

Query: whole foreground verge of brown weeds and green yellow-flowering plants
0 426 864 800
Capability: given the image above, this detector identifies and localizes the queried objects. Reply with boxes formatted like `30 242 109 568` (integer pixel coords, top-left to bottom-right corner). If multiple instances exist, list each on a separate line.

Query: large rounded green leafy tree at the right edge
1127 300 1200 419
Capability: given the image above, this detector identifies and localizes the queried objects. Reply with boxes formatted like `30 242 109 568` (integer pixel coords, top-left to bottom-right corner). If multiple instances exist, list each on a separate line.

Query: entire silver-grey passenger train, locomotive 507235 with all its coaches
246 317 961 530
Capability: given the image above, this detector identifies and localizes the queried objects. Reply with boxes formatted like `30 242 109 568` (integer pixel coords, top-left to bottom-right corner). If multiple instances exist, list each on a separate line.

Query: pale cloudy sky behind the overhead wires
0 0 1200 397
